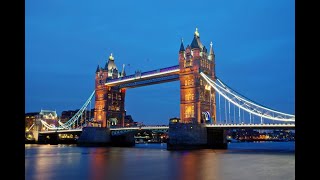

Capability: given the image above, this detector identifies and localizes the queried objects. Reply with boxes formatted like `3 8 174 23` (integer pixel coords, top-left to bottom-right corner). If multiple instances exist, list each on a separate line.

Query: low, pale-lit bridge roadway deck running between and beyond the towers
39 124 295 134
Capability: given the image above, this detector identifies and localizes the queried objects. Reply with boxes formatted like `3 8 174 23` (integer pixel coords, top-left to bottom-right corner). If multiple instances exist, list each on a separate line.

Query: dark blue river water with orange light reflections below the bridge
25 142 295 180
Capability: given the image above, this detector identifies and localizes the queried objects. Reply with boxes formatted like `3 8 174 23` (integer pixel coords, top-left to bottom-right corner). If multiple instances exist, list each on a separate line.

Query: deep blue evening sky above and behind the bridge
25 0 295 124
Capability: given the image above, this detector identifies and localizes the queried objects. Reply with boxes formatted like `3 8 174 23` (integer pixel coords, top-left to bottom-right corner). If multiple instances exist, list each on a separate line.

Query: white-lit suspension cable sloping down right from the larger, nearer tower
200 72 295 122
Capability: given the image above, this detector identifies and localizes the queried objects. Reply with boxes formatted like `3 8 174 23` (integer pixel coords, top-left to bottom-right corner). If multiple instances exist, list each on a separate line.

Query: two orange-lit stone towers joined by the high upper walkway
94 27 216 127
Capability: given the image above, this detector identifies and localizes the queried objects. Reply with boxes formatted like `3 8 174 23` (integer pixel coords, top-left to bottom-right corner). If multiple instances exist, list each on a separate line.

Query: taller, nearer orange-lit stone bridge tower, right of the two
179 28 216 124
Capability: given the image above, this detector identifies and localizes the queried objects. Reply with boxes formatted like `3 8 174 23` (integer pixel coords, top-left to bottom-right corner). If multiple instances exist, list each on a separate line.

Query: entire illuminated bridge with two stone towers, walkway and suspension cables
30 29 295 149
